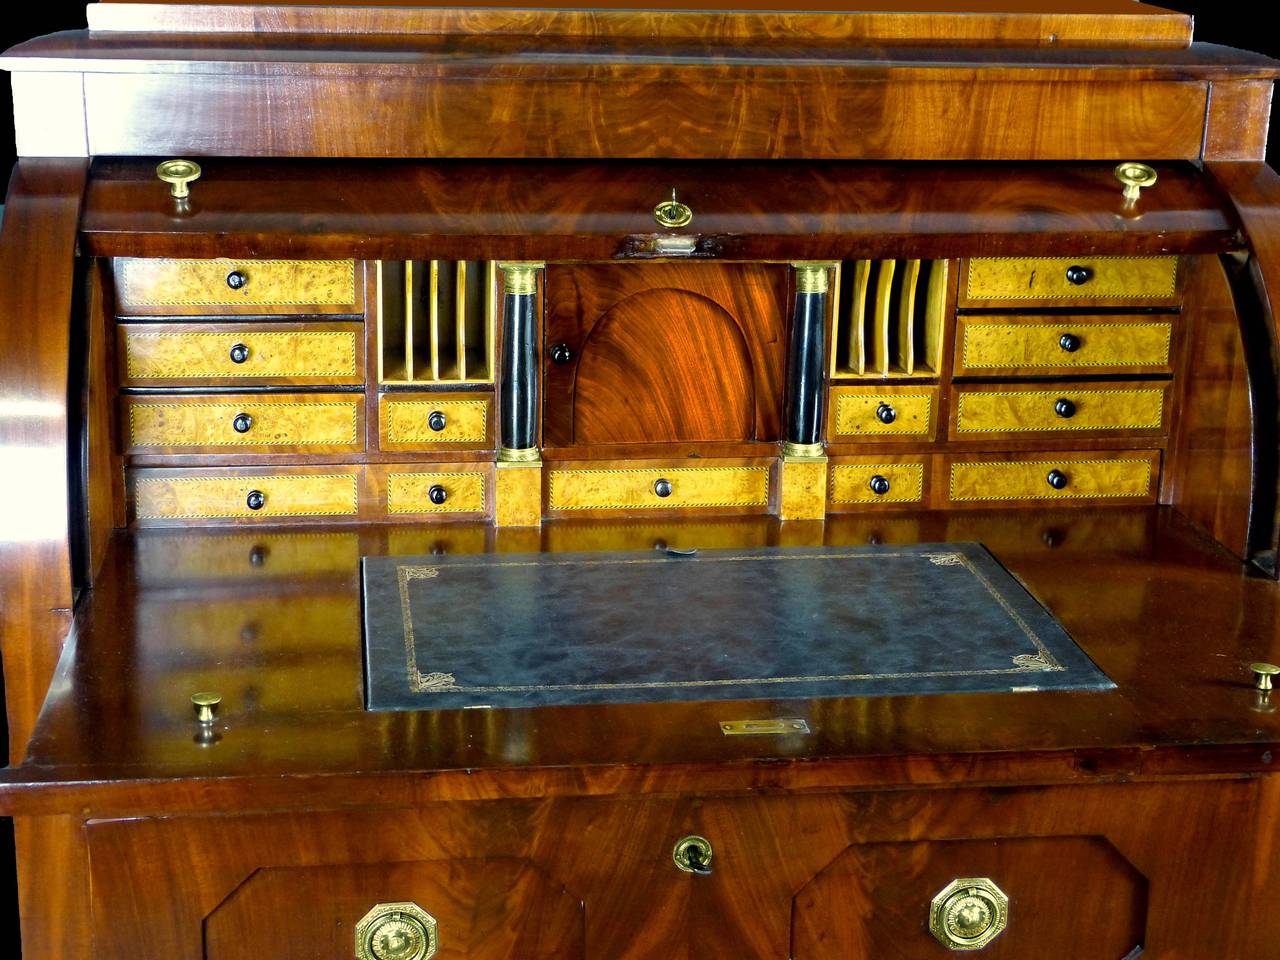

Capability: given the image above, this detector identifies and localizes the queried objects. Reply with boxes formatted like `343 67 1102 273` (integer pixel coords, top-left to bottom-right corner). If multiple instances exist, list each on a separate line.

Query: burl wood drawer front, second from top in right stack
955 316 1174 376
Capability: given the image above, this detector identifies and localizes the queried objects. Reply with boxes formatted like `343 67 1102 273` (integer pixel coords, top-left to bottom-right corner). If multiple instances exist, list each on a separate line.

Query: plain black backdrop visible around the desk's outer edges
0 0 1280 960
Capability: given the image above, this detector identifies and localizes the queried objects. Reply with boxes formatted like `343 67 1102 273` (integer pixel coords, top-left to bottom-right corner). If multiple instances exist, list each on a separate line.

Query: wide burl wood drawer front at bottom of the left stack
131 467 360 522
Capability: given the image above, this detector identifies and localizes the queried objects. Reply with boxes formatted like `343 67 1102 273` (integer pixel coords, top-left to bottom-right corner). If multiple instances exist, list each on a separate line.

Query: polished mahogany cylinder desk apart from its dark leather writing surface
0 0 1280 960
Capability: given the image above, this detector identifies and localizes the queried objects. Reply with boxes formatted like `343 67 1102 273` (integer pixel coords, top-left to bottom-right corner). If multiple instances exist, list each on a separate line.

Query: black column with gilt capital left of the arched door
498 264 543 462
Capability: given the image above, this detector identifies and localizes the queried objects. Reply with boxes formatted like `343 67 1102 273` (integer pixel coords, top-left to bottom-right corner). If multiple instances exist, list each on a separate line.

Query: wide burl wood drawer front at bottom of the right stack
947 451 1160 506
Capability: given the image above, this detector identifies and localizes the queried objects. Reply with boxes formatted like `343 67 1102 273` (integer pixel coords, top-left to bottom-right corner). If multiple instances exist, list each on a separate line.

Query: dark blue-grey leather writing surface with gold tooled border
364 543 1114 710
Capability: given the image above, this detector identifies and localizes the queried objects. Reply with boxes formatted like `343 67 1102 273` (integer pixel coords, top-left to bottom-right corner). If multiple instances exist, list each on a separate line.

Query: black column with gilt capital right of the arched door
782 264 831 456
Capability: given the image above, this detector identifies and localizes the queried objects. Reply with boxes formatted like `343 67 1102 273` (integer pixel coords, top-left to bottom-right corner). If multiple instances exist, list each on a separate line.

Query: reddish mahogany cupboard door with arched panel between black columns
543 264 787 447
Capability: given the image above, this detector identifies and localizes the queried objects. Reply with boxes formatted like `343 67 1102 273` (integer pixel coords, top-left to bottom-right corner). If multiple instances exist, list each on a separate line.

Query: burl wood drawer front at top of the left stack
115 257 364 314
